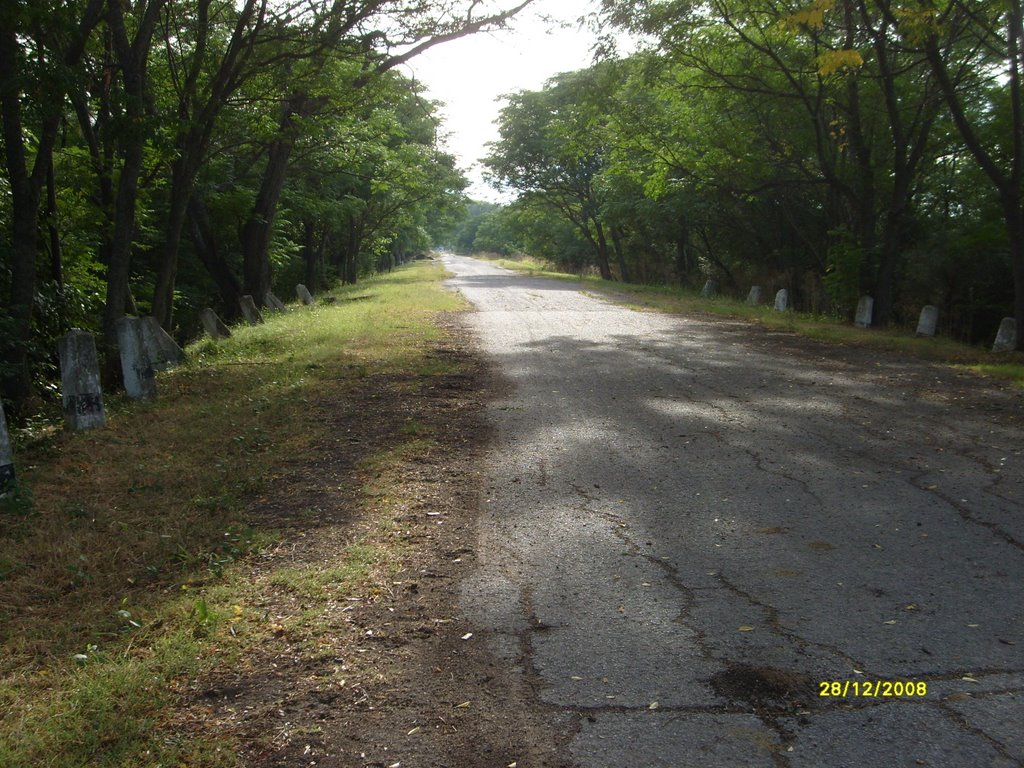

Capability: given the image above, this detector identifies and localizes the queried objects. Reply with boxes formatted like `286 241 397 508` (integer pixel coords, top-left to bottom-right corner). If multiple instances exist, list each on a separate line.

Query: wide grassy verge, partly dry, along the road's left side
0 264 461 768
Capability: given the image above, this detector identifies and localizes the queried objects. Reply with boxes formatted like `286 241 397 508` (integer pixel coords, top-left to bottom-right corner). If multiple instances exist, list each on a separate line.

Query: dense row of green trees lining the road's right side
460 0 1024 348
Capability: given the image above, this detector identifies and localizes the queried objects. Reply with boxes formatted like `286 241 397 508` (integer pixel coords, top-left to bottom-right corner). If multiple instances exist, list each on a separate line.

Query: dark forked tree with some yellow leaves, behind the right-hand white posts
604 0 939 325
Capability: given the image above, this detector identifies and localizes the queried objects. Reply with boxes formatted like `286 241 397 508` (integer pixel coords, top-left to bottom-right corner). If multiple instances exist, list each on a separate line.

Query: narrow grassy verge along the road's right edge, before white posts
479 257 1024 388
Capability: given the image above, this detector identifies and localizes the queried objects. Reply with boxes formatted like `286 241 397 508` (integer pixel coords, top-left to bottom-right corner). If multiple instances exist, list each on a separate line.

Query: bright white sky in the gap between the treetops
407 0 598 201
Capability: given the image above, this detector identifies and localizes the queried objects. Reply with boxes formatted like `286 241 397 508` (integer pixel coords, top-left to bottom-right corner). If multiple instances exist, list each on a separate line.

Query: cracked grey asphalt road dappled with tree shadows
444 256 1024 768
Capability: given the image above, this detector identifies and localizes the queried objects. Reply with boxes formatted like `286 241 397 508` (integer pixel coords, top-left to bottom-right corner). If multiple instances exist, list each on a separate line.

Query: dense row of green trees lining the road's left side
0 0 529 406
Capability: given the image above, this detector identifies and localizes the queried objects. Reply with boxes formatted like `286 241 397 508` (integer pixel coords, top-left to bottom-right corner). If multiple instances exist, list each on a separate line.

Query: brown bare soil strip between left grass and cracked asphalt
171 318 567 768
